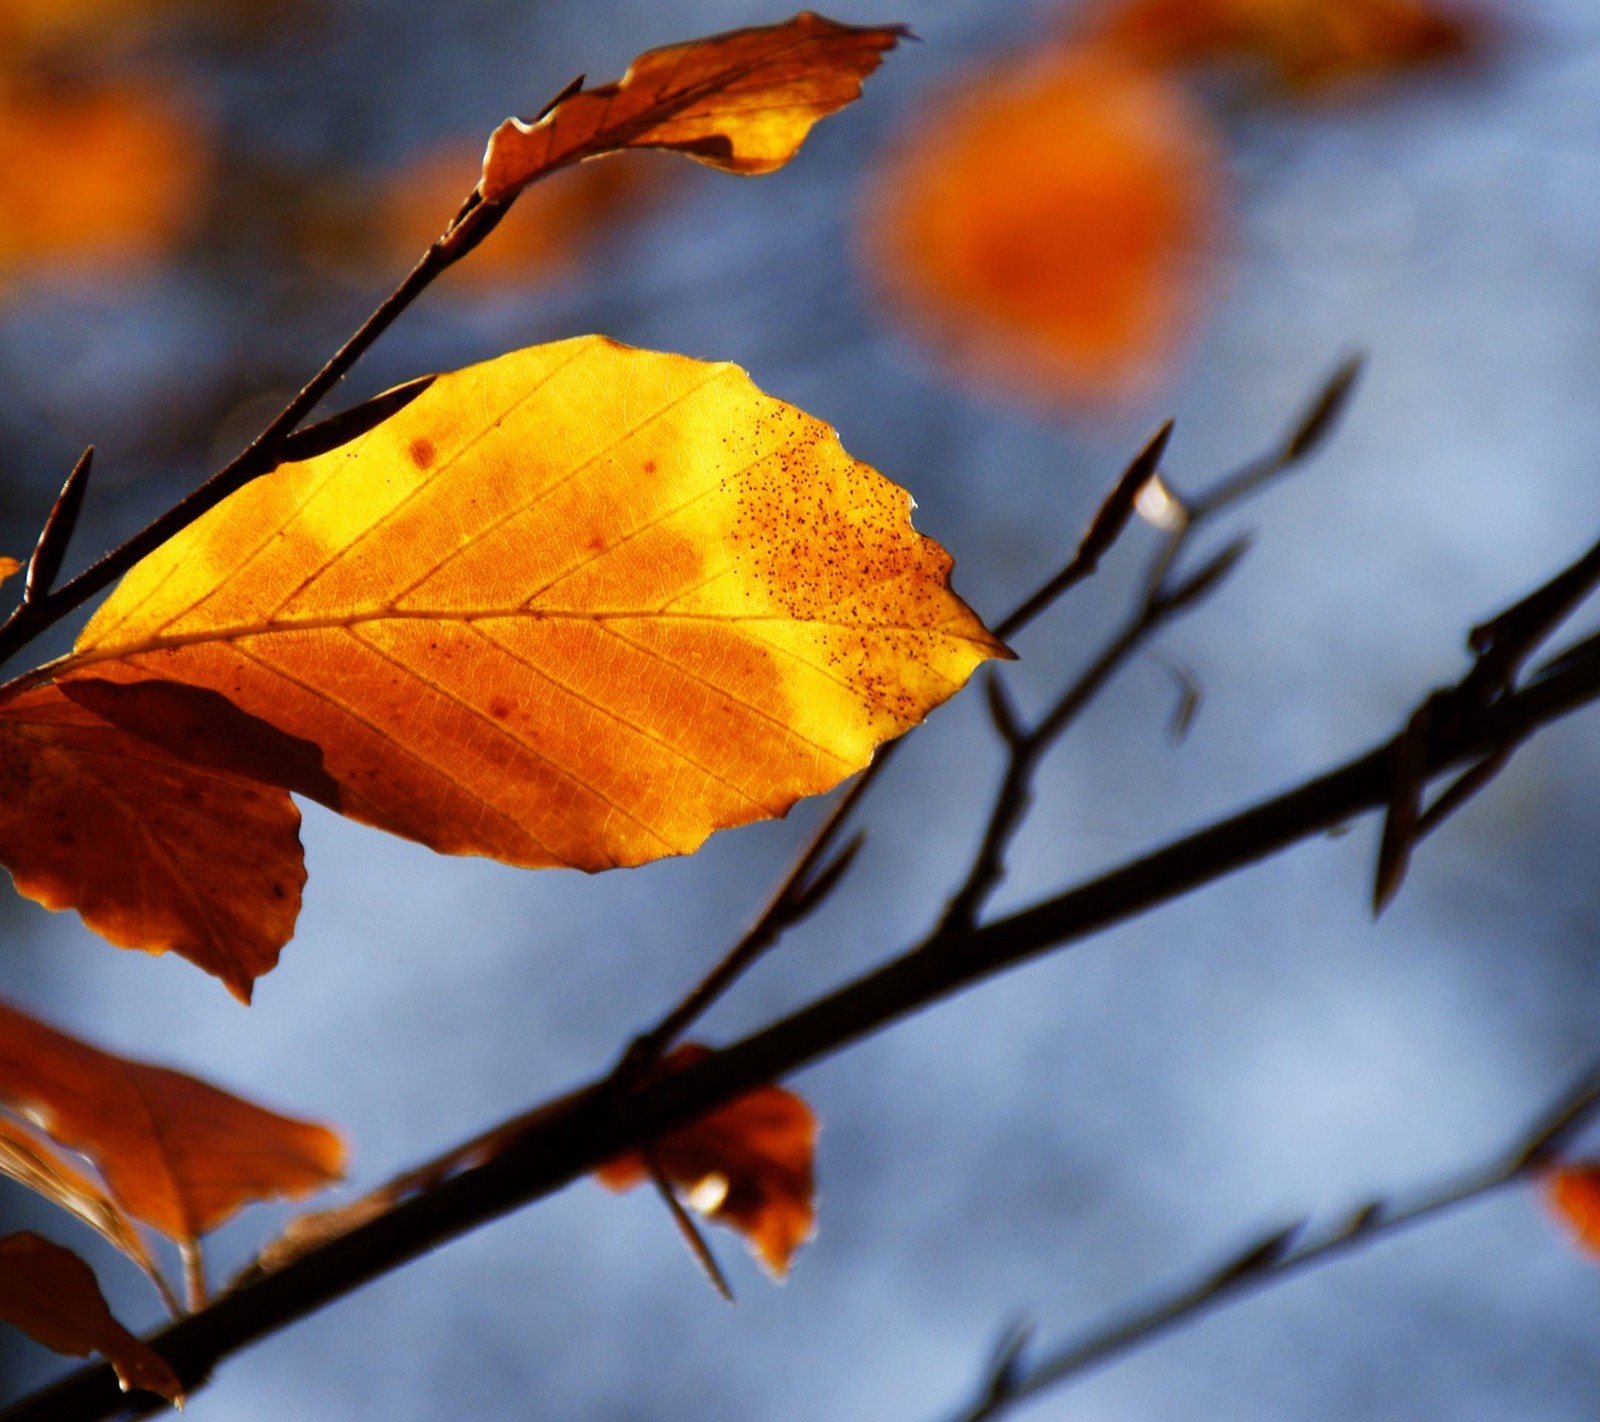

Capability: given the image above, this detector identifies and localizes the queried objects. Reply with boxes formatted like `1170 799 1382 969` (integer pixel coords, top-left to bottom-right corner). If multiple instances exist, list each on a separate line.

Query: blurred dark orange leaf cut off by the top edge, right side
1090 0 1483 88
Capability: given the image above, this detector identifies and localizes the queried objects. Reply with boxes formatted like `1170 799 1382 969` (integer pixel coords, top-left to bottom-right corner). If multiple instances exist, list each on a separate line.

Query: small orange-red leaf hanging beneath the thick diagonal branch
595 1043 816 1278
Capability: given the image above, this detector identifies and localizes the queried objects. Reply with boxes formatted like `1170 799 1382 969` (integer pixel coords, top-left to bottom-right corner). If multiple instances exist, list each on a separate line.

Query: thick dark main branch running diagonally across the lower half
15 540 1600 1422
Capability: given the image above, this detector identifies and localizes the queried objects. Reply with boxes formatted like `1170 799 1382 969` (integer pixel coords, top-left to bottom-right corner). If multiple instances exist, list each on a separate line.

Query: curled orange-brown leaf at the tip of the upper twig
478 11 906 202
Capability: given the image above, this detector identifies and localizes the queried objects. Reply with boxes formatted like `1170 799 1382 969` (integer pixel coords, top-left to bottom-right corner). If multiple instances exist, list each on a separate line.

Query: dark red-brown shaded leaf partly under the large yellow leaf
0 686 306 1001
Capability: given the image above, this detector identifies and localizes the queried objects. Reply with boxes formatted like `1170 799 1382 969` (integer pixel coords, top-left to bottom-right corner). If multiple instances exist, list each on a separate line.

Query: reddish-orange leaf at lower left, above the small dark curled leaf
0 1003 344 1243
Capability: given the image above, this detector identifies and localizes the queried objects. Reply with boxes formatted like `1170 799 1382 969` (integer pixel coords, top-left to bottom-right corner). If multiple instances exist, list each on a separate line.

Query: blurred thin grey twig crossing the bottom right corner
952 1064 1600 1422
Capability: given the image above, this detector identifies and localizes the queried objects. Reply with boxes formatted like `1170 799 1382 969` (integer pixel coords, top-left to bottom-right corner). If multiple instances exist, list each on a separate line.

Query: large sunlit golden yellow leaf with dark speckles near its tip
58 336 1008 869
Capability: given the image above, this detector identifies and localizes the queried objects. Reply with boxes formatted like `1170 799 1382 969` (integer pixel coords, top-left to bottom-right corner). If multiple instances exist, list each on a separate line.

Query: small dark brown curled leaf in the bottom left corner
0 1233 184 1408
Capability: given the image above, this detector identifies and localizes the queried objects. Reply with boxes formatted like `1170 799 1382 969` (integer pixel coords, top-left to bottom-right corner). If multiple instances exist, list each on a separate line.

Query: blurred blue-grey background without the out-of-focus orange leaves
0 0 1600 1422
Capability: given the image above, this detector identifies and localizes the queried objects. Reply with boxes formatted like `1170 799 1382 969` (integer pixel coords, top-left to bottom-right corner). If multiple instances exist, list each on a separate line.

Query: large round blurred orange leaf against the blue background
867 50 1222 406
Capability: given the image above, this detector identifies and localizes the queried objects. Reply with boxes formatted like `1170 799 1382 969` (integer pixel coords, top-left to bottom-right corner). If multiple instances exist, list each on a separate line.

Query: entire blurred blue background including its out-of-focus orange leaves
15 0 1600 1422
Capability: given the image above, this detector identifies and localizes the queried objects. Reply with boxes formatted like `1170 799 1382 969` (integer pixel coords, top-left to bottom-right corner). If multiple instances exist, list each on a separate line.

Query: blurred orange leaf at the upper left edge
0 85 211 288
